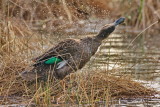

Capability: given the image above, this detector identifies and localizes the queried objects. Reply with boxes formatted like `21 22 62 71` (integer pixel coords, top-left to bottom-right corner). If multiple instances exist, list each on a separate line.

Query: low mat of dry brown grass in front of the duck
0 62 156 105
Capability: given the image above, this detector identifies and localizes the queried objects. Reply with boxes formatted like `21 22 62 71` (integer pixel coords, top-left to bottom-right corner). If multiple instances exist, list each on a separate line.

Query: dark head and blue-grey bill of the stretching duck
96 18 125 40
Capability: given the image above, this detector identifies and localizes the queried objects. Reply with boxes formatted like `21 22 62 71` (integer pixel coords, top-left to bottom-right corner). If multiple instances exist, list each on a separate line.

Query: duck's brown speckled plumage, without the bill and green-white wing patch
21 17 125 80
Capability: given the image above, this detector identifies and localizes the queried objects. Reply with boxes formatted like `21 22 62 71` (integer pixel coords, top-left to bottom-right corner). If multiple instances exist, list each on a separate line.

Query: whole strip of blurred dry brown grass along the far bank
0 0 160 32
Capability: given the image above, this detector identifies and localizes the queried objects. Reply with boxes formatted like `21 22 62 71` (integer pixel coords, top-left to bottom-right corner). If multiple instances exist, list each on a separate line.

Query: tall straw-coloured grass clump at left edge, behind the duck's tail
0 18 49 101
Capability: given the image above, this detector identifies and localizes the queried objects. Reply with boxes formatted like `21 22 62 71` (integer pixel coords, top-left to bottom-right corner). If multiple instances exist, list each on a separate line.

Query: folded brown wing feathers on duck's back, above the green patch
33 39 79 65
